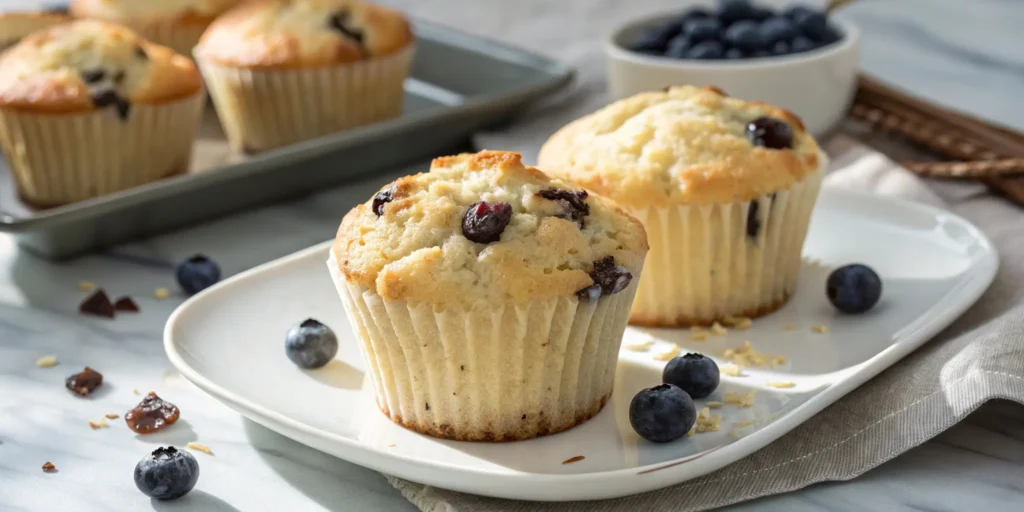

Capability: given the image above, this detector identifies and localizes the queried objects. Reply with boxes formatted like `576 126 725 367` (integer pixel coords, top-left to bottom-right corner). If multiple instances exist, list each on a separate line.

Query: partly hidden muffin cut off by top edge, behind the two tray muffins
71 0 242 56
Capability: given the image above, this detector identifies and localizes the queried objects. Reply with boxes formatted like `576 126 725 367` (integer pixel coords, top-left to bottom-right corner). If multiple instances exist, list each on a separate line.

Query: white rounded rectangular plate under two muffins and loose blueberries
164 189 998 501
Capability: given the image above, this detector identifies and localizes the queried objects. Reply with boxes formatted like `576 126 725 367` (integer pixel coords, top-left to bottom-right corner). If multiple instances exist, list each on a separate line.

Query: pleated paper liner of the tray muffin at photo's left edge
0 91 206 208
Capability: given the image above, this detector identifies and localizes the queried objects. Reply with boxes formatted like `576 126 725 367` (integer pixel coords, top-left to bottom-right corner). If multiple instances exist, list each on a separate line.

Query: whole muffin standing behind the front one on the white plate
540 87 825 327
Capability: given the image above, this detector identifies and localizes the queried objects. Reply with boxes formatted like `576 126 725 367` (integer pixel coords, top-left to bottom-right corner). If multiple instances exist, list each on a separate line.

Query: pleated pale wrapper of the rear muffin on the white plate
630 171 821 327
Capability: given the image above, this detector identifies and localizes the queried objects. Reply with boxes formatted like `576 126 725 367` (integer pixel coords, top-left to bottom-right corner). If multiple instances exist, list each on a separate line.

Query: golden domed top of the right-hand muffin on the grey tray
196 0 413 68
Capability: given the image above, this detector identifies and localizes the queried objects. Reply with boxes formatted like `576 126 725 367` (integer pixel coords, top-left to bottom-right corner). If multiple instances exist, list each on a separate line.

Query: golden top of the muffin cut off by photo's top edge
71 0 242 25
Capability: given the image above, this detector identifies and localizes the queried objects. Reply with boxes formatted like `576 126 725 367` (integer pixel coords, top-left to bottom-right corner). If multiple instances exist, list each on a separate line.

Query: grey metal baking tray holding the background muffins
0 19 573 259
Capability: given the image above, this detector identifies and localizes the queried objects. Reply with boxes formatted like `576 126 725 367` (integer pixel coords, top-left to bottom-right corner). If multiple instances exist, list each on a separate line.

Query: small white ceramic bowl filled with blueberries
605 14 860 136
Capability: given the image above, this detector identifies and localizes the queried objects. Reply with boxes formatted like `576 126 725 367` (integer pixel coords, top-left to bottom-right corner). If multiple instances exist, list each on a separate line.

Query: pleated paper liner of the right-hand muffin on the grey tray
196 45 415 153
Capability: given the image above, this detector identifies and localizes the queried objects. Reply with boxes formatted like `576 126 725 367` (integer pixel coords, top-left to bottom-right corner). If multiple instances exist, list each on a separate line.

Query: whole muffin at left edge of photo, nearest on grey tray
0 20 205 207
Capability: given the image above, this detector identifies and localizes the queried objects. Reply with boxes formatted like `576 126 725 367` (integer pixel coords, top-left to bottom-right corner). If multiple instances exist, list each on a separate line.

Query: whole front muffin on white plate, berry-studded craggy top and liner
328 152 647 441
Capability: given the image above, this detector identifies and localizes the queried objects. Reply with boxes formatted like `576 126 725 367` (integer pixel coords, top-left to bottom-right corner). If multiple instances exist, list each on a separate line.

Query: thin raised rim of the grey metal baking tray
0 16 577 234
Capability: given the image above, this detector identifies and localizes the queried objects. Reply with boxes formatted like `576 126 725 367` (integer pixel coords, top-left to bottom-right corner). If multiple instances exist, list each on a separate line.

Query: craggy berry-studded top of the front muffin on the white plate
334 152 647 307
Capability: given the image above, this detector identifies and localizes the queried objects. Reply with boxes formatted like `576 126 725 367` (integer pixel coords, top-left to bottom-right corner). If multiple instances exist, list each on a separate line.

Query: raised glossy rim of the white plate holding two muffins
164 187 998 502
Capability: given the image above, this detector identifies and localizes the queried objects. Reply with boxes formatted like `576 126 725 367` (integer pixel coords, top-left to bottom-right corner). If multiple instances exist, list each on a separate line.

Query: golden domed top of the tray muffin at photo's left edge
0 20 202 113
